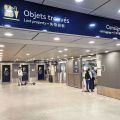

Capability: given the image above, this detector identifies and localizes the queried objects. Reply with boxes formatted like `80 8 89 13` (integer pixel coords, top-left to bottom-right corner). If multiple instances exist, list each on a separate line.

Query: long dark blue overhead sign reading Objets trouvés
0 0 120 39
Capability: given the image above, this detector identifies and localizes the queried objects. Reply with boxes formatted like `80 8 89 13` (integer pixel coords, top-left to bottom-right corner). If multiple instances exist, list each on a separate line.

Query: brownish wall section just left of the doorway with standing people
66 59 82 88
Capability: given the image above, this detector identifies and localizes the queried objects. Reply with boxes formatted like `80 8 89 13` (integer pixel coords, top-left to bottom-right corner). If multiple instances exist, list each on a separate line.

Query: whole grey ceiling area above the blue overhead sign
26 0 120 20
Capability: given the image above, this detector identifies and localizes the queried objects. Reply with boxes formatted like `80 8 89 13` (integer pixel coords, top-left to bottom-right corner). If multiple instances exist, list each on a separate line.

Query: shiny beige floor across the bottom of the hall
0 83 120 120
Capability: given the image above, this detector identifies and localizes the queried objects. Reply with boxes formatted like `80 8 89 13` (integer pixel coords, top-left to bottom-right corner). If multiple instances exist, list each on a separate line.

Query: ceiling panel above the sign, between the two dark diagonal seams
44 0 108 13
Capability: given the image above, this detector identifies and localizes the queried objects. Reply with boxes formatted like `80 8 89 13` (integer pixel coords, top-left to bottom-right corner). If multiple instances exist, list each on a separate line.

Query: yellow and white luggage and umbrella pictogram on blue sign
4 4 19 20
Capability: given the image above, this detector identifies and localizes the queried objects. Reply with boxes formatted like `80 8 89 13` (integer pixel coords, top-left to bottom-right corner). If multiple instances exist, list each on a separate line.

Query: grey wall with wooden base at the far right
98 51 120 99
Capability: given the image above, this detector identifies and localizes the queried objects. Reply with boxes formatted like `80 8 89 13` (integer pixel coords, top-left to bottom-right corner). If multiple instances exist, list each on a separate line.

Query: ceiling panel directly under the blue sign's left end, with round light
0 28 37 40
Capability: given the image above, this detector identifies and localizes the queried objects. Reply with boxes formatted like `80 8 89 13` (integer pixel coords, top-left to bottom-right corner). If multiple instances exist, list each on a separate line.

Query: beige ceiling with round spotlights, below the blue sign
0 28 120 61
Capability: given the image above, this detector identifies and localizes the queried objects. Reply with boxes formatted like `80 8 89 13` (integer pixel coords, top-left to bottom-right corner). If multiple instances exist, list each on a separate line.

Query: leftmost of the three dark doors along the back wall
2 65 10 82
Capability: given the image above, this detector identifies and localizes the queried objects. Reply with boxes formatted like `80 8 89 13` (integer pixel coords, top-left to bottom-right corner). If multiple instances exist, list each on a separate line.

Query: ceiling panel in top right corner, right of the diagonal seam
92 0 120 20
